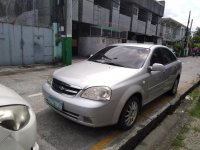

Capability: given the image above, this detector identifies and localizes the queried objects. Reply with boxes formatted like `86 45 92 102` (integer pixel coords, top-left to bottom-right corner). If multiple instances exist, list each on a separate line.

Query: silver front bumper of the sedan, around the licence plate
43 83 117 127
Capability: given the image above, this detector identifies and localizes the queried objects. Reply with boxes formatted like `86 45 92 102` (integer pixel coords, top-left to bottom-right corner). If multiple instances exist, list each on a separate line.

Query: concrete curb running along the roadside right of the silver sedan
104 80 200 150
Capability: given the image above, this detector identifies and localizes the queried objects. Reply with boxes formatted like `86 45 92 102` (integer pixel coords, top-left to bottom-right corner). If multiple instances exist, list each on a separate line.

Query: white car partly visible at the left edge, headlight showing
0 84 39 150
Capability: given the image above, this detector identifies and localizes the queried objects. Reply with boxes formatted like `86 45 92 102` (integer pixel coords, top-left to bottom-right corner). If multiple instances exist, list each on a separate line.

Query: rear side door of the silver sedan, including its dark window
161 48 177 92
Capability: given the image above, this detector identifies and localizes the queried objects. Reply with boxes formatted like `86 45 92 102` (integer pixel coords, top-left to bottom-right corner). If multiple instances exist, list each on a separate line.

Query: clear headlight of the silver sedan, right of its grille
81 87 111 101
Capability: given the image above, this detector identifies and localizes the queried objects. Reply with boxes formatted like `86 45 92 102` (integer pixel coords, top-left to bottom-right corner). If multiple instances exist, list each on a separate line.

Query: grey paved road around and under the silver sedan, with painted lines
0 57 200 150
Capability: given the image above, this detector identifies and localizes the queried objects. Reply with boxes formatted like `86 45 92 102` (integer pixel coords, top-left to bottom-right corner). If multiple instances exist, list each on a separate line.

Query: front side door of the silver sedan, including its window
148 48 165 102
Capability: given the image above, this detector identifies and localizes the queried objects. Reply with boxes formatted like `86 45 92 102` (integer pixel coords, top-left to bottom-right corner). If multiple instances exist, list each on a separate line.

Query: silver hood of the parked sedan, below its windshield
53 61 141 88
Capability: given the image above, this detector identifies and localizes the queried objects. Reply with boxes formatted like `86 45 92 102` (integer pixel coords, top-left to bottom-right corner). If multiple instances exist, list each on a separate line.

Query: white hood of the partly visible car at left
0 84 30 107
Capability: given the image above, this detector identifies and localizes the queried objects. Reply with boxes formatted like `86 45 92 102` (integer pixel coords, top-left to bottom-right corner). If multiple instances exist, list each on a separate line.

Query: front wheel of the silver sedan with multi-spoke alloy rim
118 96 139 130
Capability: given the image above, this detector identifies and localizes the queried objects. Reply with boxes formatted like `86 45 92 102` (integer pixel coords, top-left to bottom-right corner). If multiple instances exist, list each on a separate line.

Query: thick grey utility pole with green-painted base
62 0 72 65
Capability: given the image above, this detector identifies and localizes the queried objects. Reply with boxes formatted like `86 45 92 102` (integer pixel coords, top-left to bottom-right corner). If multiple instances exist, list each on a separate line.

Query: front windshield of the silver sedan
88 46 150 69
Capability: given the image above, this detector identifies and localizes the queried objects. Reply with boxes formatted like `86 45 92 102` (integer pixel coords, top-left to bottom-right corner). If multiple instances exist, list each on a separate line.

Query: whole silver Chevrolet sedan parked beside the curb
43 44 182 129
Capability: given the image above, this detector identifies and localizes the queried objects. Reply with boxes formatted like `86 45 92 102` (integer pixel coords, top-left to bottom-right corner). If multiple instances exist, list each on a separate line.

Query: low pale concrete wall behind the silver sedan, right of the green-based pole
78 37 121 57
